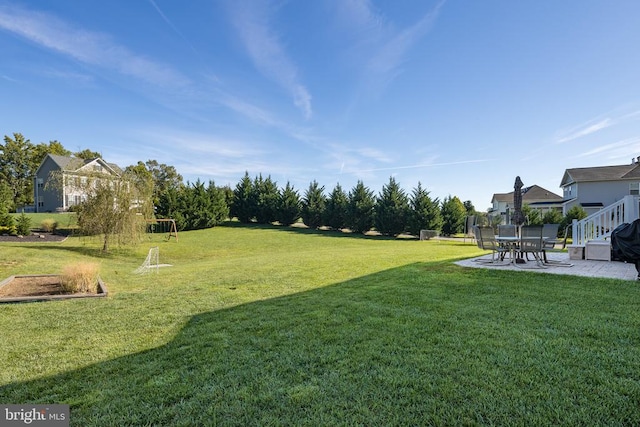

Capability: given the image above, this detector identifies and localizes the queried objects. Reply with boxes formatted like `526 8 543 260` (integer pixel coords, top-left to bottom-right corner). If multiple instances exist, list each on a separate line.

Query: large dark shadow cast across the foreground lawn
0 262 640 426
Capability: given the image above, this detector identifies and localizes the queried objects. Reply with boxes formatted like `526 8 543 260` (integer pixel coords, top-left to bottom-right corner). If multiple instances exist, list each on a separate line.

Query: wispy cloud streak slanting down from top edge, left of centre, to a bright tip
231 0 313 119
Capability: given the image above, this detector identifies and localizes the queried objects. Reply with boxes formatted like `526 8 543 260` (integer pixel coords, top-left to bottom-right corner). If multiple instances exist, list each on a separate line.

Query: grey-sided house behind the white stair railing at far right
560 158 640 214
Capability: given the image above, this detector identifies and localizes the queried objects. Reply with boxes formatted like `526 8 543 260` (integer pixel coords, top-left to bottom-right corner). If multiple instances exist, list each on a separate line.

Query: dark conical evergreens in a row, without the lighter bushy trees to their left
225 172 460 236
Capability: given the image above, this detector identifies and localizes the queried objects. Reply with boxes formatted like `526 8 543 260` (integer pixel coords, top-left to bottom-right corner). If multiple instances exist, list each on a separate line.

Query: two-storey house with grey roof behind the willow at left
33 154 122 212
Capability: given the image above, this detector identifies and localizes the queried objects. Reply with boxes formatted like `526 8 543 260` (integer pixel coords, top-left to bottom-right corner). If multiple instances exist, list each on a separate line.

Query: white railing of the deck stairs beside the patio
571 196 640 246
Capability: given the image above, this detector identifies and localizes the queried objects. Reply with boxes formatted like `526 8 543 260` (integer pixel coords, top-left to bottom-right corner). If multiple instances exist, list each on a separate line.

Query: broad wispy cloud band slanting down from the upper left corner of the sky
0 5 189 88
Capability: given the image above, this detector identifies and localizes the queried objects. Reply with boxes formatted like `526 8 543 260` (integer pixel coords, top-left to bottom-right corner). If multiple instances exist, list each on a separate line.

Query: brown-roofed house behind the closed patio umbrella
487 185 562 224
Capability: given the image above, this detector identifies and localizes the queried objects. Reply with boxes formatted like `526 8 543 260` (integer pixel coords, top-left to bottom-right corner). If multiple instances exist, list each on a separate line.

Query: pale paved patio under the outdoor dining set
456 253 638 281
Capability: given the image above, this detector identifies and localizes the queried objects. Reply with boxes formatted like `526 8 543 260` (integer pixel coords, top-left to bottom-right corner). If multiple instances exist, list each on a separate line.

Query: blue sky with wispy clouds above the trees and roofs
0 0 640 210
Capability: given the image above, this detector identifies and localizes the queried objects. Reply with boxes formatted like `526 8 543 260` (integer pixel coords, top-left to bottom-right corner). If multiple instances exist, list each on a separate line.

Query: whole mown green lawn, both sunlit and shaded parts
0 226 640 426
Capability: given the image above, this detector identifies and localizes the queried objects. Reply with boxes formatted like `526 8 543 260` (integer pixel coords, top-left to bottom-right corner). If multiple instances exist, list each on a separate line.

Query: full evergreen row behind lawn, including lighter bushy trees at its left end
156 172 473 236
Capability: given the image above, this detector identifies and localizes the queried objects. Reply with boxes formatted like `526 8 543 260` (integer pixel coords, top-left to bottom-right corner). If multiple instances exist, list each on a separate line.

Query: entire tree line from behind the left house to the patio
0 133 477 239
